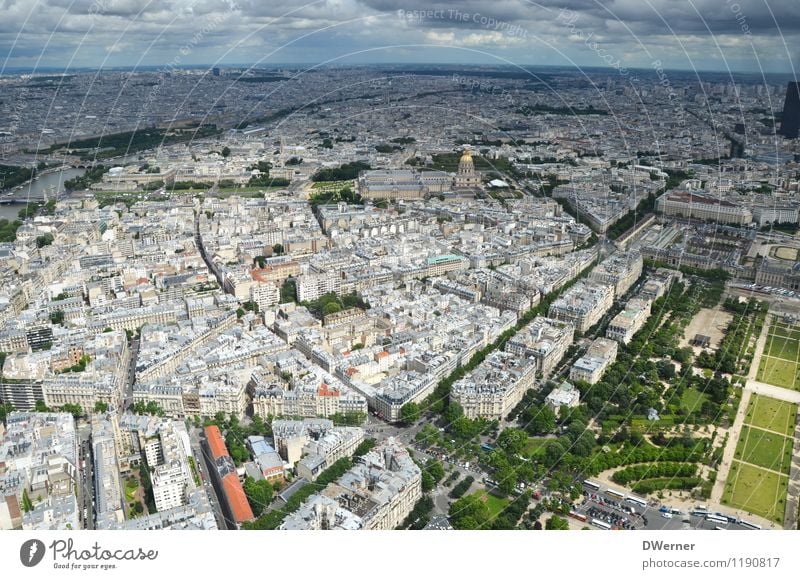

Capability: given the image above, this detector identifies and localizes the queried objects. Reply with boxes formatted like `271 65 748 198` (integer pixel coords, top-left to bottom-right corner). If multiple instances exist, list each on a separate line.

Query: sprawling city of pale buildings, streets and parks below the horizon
0 57 800 530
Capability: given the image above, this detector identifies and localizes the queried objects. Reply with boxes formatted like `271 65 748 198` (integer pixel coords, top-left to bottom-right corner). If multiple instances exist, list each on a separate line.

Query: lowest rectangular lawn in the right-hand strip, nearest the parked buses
722 461 789 524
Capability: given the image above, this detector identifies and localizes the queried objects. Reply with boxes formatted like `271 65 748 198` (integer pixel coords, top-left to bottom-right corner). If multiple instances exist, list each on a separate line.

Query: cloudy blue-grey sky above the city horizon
0 0 800 75
